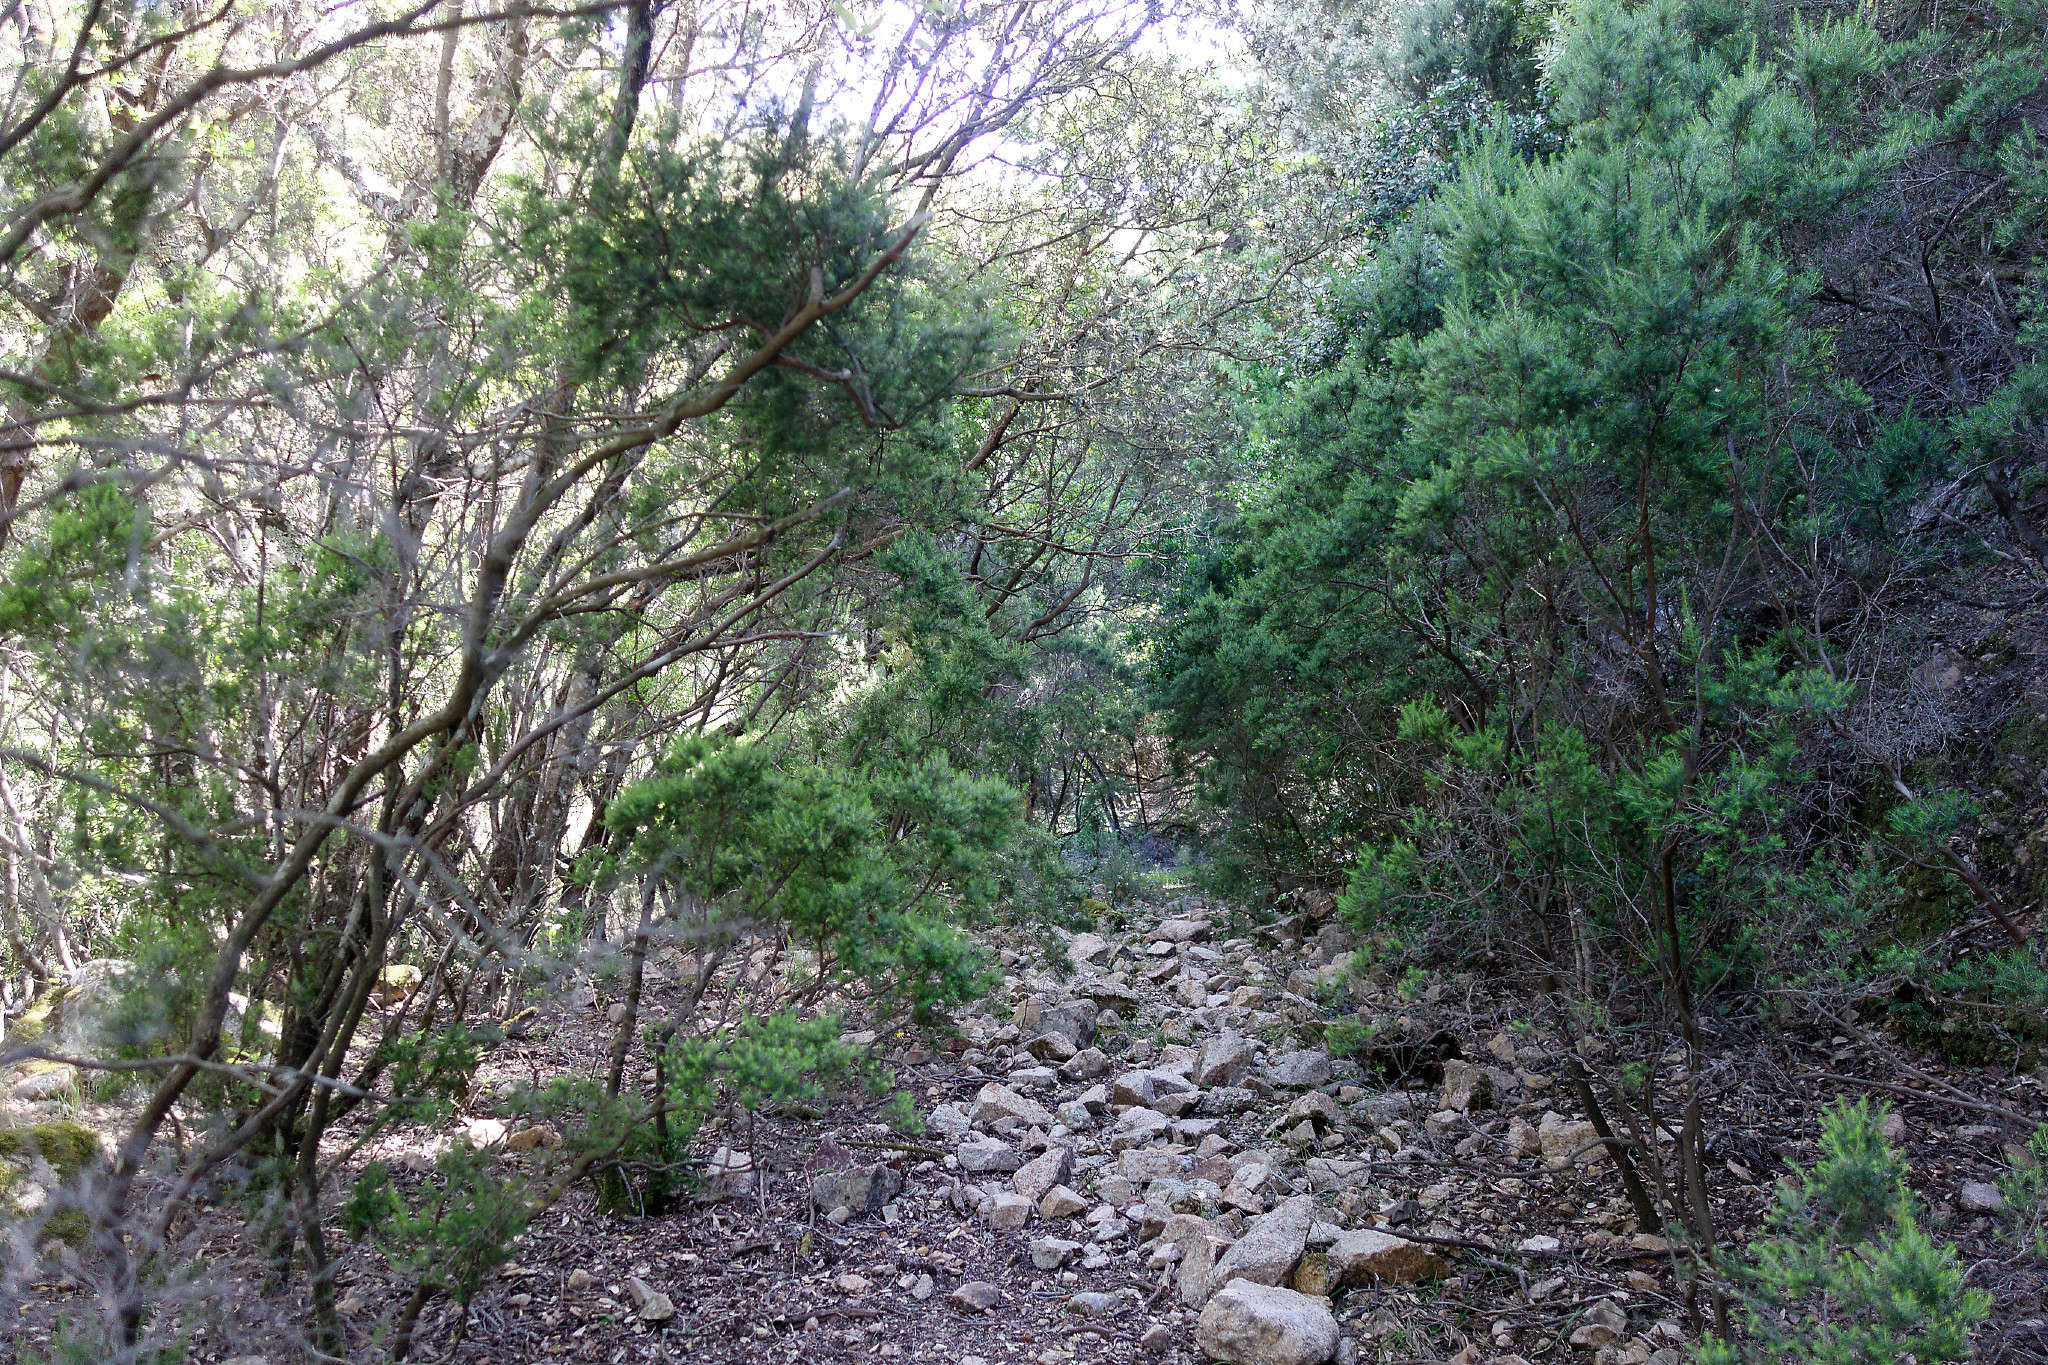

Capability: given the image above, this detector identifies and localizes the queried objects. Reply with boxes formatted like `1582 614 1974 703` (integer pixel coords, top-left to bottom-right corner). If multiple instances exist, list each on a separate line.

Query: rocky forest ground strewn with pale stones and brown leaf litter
18 898 2048 1365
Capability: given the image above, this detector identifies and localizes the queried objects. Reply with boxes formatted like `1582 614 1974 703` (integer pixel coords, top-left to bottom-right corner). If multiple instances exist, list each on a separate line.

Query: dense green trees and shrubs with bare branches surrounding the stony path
0 0 2048 1359
